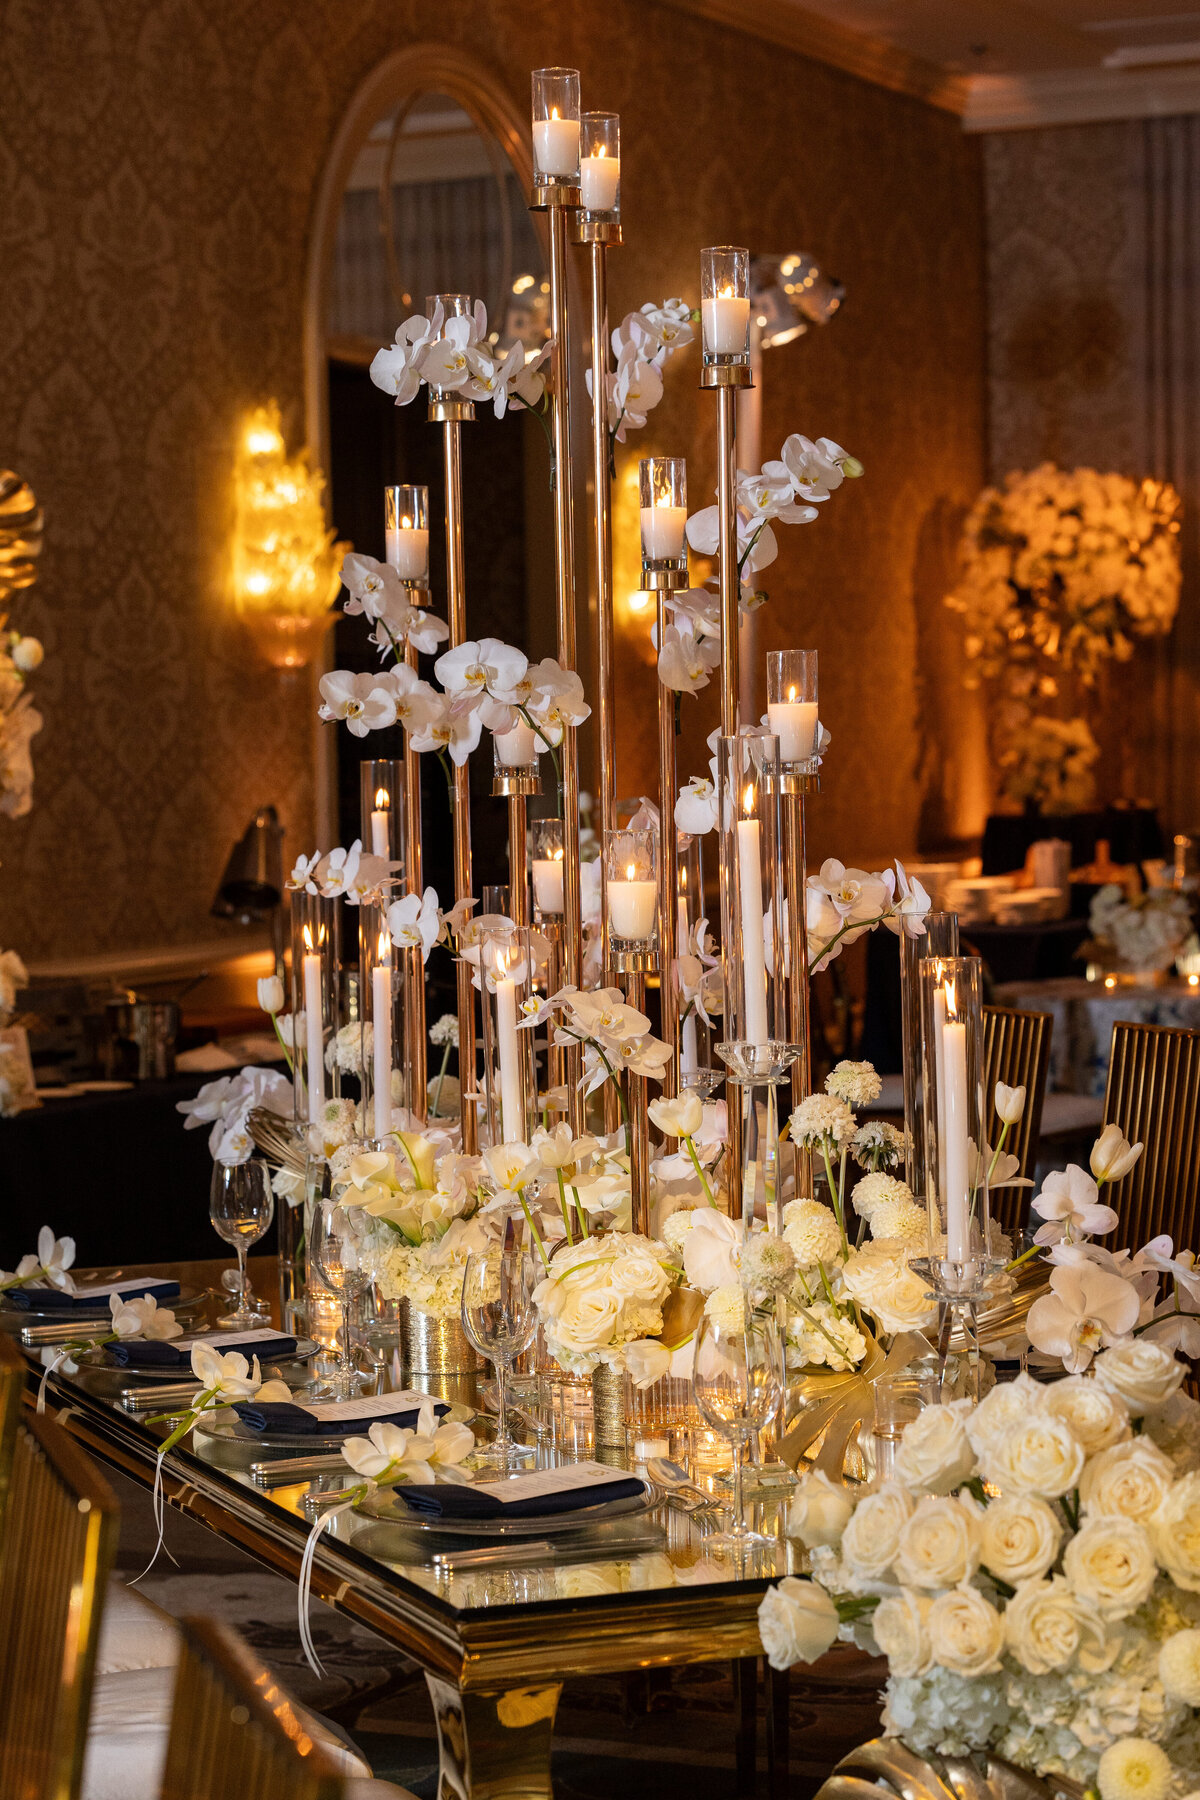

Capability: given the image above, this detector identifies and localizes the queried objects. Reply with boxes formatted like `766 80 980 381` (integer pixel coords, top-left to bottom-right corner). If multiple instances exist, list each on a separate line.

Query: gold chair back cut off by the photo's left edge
0 1415 119 1800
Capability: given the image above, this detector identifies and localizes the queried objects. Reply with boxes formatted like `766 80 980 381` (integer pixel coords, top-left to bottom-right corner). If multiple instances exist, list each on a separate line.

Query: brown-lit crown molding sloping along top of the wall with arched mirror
662 0 971 117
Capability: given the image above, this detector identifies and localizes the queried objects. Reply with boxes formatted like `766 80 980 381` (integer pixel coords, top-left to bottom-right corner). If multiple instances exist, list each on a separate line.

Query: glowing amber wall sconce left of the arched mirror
232 401 351 670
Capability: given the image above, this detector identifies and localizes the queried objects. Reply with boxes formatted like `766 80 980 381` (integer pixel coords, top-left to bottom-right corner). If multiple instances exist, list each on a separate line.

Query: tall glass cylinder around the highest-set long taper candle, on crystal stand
716 734 788 1049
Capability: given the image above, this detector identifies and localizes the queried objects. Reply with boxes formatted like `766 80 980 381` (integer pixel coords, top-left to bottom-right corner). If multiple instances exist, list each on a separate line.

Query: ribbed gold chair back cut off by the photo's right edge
1103 1021 1200 1249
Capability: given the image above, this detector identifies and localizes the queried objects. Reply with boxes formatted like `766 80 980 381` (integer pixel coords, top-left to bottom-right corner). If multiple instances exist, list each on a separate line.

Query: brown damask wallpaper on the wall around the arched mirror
0 0 982 958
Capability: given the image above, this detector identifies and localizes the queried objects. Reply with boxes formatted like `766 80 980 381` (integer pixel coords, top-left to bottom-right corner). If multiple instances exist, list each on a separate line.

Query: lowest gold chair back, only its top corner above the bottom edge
162 1618 345 1800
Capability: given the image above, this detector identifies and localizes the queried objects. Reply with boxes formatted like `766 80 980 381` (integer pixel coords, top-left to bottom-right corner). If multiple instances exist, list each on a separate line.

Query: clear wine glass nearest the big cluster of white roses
693 1305 783 1550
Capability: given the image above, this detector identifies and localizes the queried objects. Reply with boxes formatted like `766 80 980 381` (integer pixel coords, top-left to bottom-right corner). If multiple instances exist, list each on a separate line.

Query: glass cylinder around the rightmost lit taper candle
919 956 995 1294
